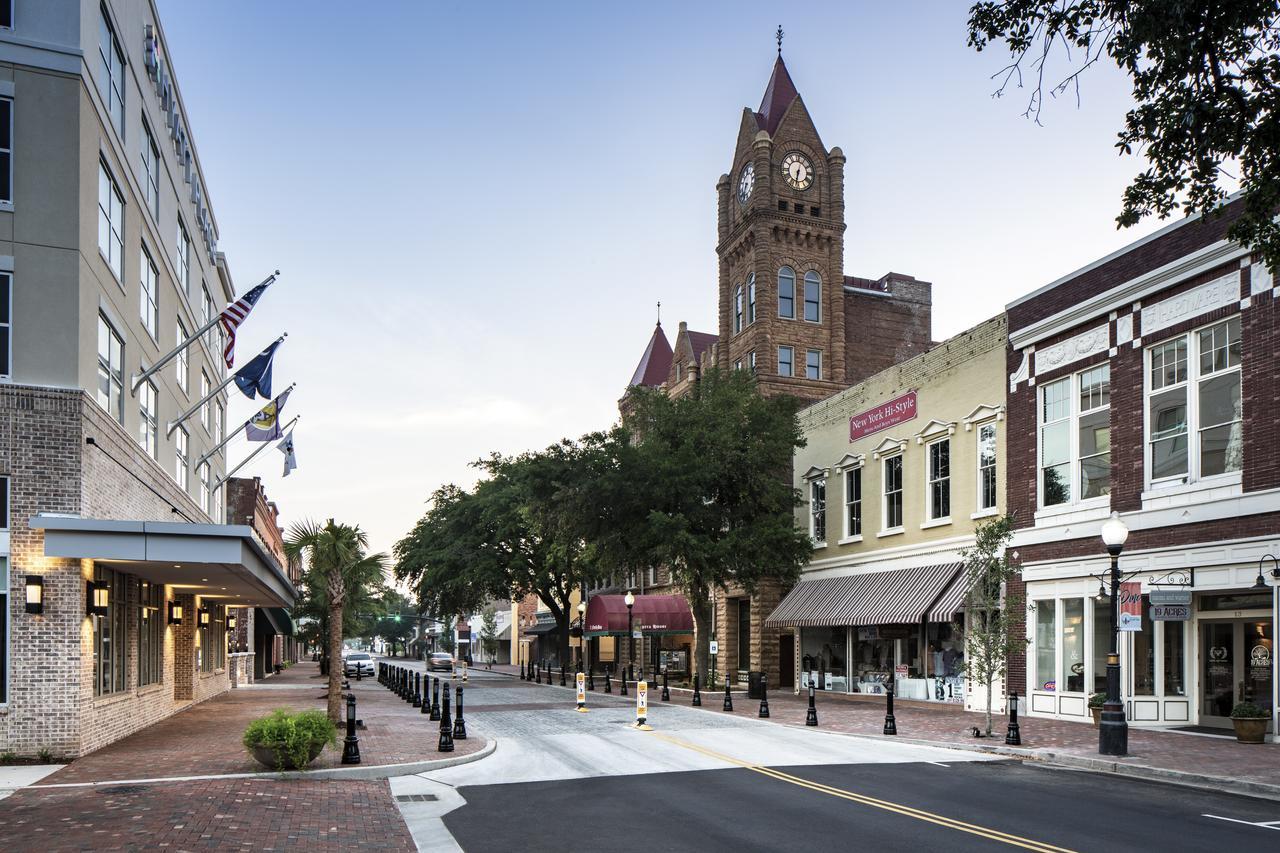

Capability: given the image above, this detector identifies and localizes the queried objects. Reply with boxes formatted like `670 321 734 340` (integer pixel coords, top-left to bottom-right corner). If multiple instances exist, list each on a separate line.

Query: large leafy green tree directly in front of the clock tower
606 370 813 674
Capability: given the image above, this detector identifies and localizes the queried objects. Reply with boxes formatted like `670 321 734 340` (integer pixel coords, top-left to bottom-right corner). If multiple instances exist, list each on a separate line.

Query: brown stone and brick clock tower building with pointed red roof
631 54 932 684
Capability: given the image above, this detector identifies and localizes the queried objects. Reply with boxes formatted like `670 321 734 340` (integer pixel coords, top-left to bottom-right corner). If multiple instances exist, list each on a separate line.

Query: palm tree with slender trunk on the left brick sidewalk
284 519 387 722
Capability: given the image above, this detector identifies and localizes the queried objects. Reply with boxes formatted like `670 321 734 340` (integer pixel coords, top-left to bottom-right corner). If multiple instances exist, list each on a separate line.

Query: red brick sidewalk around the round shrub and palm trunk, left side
44 661 485 784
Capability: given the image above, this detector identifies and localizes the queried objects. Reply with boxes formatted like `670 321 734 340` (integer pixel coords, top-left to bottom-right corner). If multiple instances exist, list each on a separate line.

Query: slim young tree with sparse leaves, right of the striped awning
960 515 1027 736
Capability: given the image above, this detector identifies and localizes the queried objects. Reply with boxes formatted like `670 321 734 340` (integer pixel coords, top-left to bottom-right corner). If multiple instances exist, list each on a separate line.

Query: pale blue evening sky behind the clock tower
159 0 1172 549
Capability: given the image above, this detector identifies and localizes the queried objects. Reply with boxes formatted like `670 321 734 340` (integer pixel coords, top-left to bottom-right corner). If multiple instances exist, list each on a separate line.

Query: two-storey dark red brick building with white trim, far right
1007 201 1280 726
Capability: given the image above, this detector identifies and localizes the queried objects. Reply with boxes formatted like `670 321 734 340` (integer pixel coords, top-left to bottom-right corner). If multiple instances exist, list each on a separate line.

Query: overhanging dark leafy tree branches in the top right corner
969 0 1280 268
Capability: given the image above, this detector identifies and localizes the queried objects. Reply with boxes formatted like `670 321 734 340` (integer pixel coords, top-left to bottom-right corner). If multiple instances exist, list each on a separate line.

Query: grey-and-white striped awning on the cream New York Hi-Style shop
764 562 961 628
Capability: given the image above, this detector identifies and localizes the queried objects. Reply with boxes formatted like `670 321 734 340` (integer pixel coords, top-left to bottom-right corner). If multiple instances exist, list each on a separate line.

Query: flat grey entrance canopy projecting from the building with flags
29 512 297 607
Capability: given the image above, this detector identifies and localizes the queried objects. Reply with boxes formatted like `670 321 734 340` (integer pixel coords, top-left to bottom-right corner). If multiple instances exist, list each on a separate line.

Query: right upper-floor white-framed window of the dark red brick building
1147 316 1244 485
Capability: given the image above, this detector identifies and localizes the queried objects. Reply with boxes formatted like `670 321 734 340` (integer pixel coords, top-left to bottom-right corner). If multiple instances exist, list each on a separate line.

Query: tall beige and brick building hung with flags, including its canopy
0 0 294 756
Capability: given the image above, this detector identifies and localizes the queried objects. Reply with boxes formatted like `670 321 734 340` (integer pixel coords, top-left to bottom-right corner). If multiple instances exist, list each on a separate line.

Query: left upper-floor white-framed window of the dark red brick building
1039 364 1111 506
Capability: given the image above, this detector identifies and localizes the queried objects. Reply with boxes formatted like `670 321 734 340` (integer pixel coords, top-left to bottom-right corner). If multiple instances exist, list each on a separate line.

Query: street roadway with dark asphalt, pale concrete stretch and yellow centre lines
381 676 1280 853
